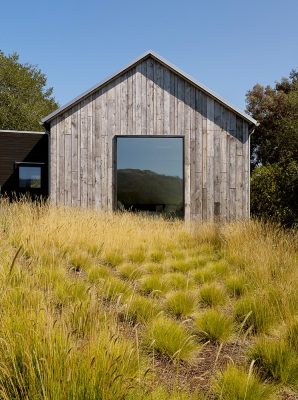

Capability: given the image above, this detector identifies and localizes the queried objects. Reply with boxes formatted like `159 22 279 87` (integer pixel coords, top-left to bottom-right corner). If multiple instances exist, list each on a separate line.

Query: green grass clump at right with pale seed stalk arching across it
235 294 272 334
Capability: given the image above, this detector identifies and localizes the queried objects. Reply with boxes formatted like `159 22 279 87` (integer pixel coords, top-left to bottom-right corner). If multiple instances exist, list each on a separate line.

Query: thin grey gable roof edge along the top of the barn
41 50 258 125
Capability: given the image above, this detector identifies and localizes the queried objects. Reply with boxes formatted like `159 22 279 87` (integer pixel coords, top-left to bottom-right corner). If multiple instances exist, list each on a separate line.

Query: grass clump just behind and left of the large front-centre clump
124 294 161 323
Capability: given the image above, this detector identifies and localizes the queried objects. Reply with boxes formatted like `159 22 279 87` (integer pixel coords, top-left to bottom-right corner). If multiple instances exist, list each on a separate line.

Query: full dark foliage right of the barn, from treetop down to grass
247 71 298 226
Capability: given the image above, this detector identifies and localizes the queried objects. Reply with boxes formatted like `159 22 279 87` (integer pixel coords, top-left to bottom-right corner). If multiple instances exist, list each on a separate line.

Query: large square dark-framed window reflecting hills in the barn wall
116 137 184 217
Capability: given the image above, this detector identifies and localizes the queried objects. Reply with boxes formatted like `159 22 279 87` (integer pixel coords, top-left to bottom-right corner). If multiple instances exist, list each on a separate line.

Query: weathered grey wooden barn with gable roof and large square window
42 52 256 221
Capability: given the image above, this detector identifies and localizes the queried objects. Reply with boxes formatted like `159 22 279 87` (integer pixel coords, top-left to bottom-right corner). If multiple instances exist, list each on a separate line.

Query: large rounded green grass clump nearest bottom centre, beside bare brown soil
146 317 196 360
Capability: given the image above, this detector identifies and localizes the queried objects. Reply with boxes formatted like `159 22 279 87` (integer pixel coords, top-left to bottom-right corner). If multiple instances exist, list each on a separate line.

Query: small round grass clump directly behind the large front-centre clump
165 290 197 318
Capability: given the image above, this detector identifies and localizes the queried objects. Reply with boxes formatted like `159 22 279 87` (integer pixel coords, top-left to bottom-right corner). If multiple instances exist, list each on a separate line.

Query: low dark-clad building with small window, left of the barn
0 130 48 198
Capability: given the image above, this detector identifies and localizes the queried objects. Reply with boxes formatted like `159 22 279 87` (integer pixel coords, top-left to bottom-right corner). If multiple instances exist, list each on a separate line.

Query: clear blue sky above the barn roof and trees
0 0 298 109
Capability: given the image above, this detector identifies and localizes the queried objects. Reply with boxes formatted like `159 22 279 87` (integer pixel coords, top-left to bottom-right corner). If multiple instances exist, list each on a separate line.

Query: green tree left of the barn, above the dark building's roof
0 51 58 131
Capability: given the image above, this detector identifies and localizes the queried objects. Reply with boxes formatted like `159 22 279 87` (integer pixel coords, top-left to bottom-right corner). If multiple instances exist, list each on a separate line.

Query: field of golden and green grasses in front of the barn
0 200 298 400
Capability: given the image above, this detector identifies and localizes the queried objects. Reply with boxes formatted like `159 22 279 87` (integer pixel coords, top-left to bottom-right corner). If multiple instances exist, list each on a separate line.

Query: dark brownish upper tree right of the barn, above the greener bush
246 70 298 169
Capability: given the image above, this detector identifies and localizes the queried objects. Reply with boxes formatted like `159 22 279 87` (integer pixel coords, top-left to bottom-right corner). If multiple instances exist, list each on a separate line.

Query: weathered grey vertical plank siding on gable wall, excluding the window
50 58 249 221
